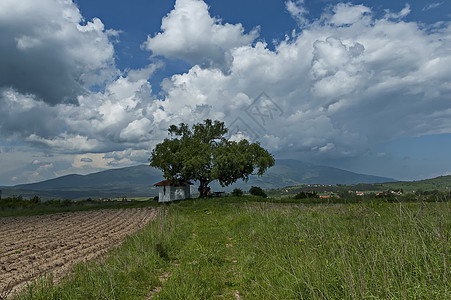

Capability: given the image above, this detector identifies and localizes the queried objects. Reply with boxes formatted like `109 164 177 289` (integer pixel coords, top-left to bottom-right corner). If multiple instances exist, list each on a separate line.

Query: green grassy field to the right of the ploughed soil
12 196 451 299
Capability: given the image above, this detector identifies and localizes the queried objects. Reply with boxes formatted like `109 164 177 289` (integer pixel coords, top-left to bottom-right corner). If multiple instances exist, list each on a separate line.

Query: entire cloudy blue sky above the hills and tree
0 0 451 186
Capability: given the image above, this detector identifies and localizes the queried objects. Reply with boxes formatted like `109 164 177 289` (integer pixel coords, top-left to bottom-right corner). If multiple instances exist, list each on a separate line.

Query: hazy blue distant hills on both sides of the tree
3 159 395 199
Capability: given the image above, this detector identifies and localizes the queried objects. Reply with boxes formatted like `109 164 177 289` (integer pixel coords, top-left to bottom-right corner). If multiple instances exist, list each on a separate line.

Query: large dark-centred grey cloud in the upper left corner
0 0 118 105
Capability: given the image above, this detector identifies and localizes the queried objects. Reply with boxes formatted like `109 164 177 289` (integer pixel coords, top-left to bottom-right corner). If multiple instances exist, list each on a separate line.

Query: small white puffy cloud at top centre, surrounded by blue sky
144 0 258 71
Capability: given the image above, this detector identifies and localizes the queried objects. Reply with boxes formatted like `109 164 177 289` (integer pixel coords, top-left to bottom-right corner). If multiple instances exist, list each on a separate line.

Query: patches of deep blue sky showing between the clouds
75 0 451 90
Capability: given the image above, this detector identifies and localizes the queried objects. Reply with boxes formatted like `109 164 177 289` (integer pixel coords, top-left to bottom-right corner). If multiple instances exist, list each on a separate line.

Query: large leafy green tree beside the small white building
149 119 274 197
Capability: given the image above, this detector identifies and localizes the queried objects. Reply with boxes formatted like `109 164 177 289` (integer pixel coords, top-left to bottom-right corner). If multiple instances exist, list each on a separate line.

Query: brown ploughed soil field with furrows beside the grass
0 208 157 299
